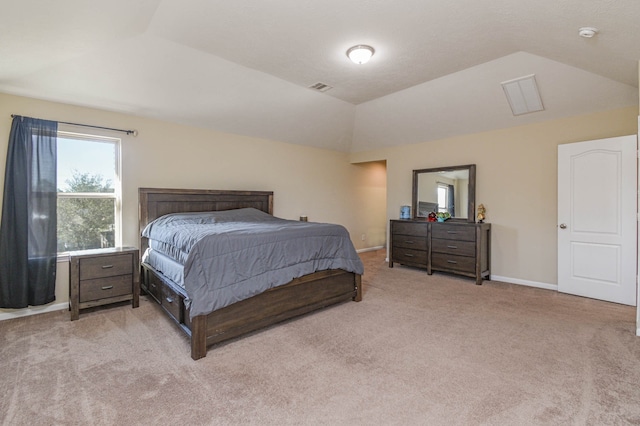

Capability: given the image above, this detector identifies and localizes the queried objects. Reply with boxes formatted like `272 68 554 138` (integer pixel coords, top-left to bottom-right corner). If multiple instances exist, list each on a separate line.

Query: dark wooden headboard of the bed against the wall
138 188 273 255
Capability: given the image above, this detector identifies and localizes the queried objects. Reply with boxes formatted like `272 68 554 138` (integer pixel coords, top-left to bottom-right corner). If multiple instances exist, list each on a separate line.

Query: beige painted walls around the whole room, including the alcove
0 94 638 315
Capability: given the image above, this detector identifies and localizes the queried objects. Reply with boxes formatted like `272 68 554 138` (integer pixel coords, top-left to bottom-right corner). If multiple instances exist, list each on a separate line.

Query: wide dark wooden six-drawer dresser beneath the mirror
389 220 491 284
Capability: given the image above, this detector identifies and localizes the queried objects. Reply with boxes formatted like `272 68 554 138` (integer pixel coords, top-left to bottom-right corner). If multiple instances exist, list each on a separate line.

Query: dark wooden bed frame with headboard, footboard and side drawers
138 188 362 359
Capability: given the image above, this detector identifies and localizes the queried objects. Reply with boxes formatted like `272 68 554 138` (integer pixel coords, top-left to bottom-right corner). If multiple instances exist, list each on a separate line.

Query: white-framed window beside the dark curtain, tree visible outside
57 131 120 253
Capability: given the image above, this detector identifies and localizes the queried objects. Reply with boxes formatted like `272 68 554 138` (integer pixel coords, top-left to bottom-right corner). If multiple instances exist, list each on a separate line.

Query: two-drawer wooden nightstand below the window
69 247 140 321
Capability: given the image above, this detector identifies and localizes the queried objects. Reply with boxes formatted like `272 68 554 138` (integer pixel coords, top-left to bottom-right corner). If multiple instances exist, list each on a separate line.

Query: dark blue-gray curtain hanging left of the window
0 116 58 308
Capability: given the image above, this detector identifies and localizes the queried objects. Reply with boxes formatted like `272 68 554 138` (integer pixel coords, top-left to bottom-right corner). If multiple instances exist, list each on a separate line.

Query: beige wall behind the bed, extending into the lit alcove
0 93 386 316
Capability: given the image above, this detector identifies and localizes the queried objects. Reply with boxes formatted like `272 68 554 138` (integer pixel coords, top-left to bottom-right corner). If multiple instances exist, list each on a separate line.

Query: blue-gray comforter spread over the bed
142 208 364 317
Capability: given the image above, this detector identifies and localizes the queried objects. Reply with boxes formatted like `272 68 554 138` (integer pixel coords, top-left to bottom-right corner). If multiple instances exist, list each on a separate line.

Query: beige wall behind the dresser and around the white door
351 107 638 286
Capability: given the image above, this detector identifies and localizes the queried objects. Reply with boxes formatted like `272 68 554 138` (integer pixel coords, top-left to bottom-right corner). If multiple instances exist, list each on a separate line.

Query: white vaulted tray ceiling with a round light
0 0 640 151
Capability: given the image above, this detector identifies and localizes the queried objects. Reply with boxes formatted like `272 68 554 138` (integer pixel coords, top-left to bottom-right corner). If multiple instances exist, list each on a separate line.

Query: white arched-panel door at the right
558 135 637 306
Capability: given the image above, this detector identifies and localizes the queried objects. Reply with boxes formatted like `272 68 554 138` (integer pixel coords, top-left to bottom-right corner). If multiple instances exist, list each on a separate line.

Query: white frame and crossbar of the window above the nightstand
57 130 122 257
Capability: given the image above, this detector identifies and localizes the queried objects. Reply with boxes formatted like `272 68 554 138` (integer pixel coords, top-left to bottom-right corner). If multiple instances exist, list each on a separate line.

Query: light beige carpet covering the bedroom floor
0 251 640 425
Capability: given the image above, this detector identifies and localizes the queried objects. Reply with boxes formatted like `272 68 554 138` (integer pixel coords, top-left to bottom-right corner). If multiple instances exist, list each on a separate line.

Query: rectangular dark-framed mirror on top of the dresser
411 164 476 222
